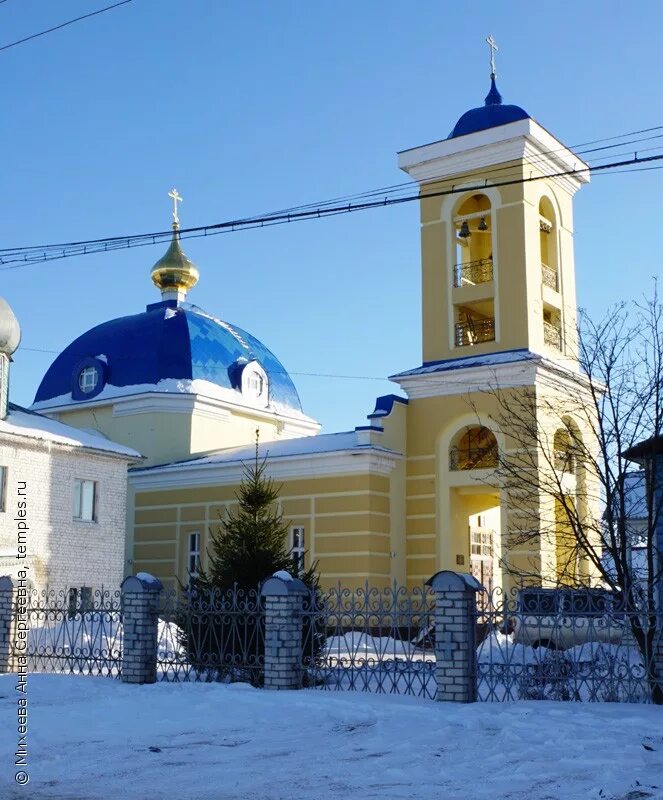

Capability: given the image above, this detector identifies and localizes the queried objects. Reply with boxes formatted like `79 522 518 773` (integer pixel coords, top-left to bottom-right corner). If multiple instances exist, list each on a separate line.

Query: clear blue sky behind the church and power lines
0 0 663 438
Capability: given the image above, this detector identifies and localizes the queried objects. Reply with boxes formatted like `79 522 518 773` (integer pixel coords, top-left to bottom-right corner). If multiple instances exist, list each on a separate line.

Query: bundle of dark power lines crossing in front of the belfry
0 154 663 270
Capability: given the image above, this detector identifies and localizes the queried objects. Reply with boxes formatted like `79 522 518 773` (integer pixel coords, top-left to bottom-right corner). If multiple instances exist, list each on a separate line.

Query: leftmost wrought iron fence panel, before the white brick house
20 589 122 678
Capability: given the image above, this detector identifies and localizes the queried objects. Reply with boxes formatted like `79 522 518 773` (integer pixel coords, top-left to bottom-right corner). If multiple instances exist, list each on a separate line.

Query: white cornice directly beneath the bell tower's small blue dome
398 119 589 194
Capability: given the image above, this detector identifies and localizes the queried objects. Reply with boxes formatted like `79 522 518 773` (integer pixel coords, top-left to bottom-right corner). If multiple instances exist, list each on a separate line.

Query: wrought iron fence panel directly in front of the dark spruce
157 587 265 686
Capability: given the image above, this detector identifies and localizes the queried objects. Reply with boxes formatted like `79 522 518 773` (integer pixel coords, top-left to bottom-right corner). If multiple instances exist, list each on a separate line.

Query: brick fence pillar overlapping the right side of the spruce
261 572 309 689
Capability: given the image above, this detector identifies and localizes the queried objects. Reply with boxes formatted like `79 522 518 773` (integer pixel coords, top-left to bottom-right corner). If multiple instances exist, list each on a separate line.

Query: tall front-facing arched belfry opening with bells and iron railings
453 194 495 347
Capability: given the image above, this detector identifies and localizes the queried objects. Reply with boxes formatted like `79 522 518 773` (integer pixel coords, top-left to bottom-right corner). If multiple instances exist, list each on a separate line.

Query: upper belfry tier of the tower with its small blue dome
399 63 589 367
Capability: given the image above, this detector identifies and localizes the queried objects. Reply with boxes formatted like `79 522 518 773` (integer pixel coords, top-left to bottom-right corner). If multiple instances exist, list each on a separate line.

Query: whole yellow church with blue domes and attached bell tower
33 56 598 587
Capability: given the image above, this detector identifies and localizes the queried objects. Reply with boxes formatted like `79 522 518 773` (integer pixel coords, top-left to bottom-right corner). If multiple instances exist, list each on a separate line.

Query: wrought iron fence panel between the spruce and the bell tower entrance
303 585 436 699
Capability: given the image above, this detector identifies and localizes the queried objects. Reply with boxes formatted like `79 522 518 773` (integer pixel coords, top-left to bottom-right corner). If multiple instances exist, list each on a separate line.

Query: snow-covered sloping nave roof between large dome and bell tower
131 431 401 473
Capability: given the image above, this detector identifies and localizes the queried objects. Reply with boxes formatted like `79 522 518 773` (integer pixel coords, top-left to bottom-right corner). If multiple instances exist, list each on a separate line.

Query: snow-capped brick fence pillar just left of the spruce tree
121 572 163 683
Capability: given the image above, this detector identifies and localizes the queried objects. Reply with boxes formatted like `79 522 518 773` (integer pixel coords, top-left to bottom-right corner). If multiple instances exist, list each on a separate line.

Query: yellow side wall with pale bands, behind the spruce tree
134 475 396 586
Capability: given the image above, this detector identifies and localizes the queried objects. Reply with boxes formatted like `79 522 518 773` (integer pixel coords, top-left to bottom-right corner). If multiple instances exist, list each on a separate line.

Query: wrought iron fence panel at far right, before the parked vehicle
476 588 663 703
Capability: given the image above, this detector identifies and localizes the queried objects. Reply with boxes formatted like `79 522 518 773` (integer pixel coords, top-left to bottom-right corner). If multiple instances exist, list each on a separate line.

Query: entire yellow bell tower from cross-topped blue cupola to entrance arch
391 43 597 588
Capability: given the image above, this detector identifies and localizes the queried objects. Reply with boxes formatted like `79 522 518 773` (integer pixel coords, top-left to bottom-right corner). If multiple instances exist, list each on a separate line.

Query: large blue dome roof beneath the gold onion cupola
34 300 301 412
